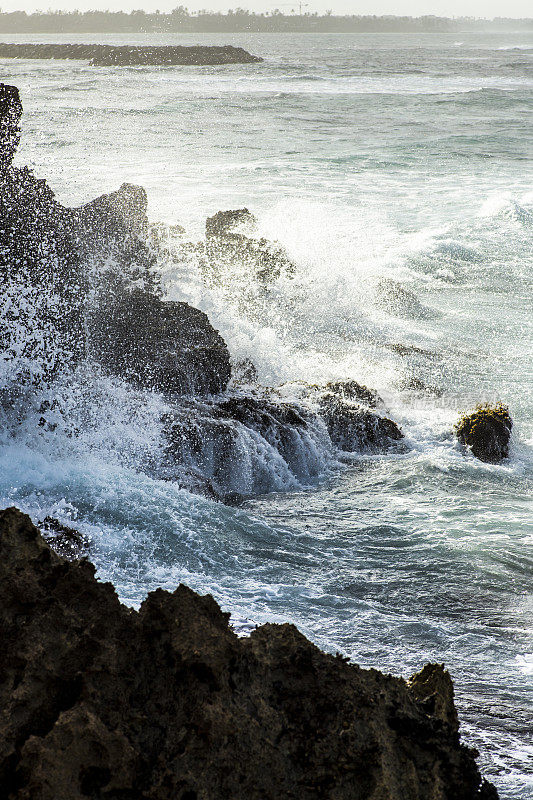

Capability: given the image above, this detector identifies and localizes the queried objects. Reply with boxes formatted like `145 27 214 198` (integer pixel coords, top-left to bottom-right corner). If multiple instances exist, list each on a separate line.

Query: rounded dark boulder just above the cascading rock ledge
89 289 231 394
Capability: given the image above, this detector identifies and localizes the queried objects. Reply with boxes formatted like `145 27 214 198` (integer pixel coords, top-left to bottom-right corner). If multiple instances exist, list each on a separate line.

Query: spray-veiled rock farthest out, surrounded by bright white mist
205 208 295 284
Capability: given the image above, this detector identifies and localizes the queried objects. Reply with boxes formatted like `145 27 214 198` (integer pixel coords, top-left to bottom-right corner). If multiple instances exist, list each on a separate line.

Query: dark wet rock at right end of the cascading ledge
320 393 403 452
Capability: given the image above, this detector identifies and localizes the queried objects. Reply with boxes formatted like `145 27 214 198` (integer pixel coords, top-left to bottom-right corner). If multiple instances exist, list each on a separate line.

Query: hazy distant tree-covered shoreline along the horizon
0 8 533 34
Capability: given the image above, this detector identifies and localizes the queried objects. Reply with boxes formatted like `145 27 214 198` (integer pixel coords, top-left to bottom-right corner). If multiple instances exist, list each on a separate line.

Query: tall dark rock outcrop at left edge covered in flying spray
0 84 230 393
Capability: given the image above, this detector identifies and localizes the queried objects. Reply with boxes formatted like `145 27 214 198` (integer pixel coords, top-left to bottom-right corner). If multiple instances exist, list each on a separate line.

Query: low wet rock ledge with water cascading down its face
162 382 403 504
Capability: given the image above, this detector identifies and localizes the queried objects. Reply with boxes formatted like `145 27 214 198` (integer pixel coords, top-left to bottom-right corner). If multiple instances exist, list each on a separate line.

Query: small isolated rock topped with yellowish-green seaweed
455 405 513 464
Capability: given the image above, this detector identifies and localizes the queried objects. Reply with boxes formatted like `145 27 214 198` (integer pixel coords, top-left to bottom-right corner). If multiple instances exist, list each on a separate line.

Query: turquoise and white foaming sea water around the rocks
0 33 533 800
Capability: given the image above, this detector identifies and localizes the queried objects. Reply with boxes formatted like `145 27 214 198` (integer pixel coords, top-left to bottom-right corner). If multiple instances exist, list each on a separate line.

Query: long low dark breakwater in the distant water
0 42 263 67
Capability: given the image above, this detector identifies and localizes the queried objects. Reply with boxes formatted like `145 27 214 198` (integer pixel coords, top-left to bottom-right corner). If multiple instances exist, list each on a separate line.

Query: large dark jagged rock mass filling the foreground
0 509 497 800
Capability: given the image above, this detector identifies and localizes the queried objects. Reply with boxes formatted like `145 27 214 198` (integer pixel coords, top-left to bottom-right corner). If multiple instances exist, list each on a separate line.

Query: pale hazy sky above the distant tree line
0 0 533 17
